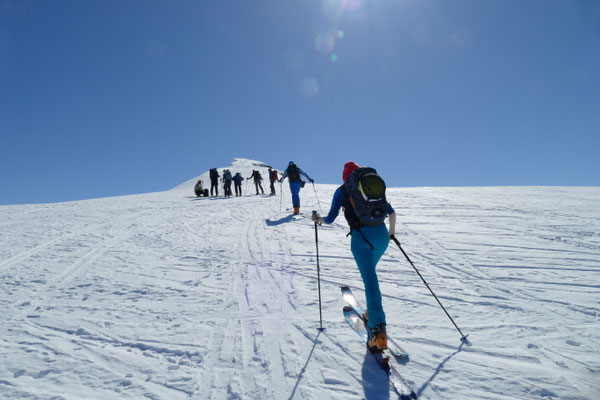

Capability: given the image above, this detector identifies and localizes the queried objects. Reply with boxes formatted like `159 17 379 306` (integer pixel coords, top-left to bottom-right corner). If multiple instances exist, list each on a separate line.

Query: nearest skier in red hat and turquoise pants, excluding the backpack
313 161 396 351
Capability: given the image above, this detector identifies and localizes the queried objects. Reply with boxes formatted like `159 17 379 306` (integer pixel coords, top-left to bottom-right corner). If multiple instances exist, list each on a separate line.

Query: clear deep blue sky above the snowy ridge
0 0 600 204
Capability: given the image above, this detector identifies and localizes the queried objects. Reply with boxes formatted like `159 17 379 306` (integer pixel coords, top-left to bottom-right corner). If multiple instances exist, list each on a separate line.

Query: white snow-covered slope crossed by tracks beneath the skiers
0 159 600 399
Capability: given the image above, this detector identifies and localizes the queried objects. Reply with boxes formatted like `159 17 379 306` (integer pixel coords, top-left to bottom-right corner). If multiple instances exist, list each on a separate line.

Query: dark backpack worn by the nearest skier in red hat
344 167 388 226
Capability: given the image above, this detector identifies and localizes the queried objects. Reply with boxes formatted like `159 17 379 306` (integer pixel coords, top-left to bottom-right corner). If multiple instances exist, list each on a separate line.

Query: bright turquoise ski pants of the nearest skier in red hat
350 224 390 328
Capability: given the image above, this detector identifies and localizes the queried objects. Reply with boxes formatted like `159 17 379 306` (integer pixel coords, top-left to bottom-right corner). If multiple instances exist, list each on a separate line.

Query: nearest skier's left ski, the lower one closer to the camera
344 306 418 400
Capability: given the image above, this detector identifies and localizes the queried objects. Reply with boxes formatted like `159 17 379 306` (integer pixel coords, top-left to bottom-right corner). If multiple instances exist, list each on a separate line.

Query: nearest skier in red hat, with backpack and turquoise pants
312 161 396 352
